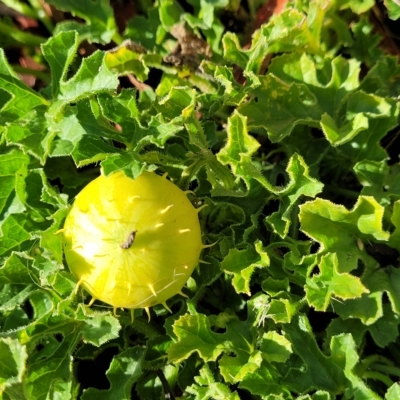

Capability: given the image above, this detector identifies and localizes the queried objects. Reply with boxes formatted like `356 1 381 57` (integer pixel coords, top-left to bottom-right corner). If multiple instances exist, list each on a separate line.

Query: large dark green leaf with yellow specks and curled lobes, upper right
239 53 393 145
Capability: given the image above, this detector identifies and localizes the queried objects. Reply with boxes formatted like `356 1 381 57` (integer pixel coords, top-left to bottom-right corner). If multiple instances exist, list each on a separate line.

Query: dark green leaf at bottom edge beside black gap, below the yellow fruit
82 346 146 400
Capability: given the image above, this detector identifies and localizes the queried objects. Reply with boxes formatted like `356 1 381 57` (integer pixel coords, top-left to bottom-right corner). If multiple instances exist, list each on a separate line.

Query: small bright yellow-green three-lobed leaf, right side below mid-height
305 253 369 311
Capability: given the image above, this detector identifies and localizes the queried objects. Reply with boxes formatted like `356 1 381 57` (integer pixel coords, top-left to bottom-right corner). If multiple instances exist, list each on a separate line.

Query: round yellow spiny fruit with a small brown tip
63 172 202 309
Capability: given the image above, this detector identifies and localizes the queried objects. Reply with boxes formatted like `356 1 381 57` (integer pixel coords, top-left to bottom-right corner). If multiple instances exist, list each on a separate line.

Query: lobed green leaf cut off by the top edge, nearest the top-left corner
48 0 119 44
